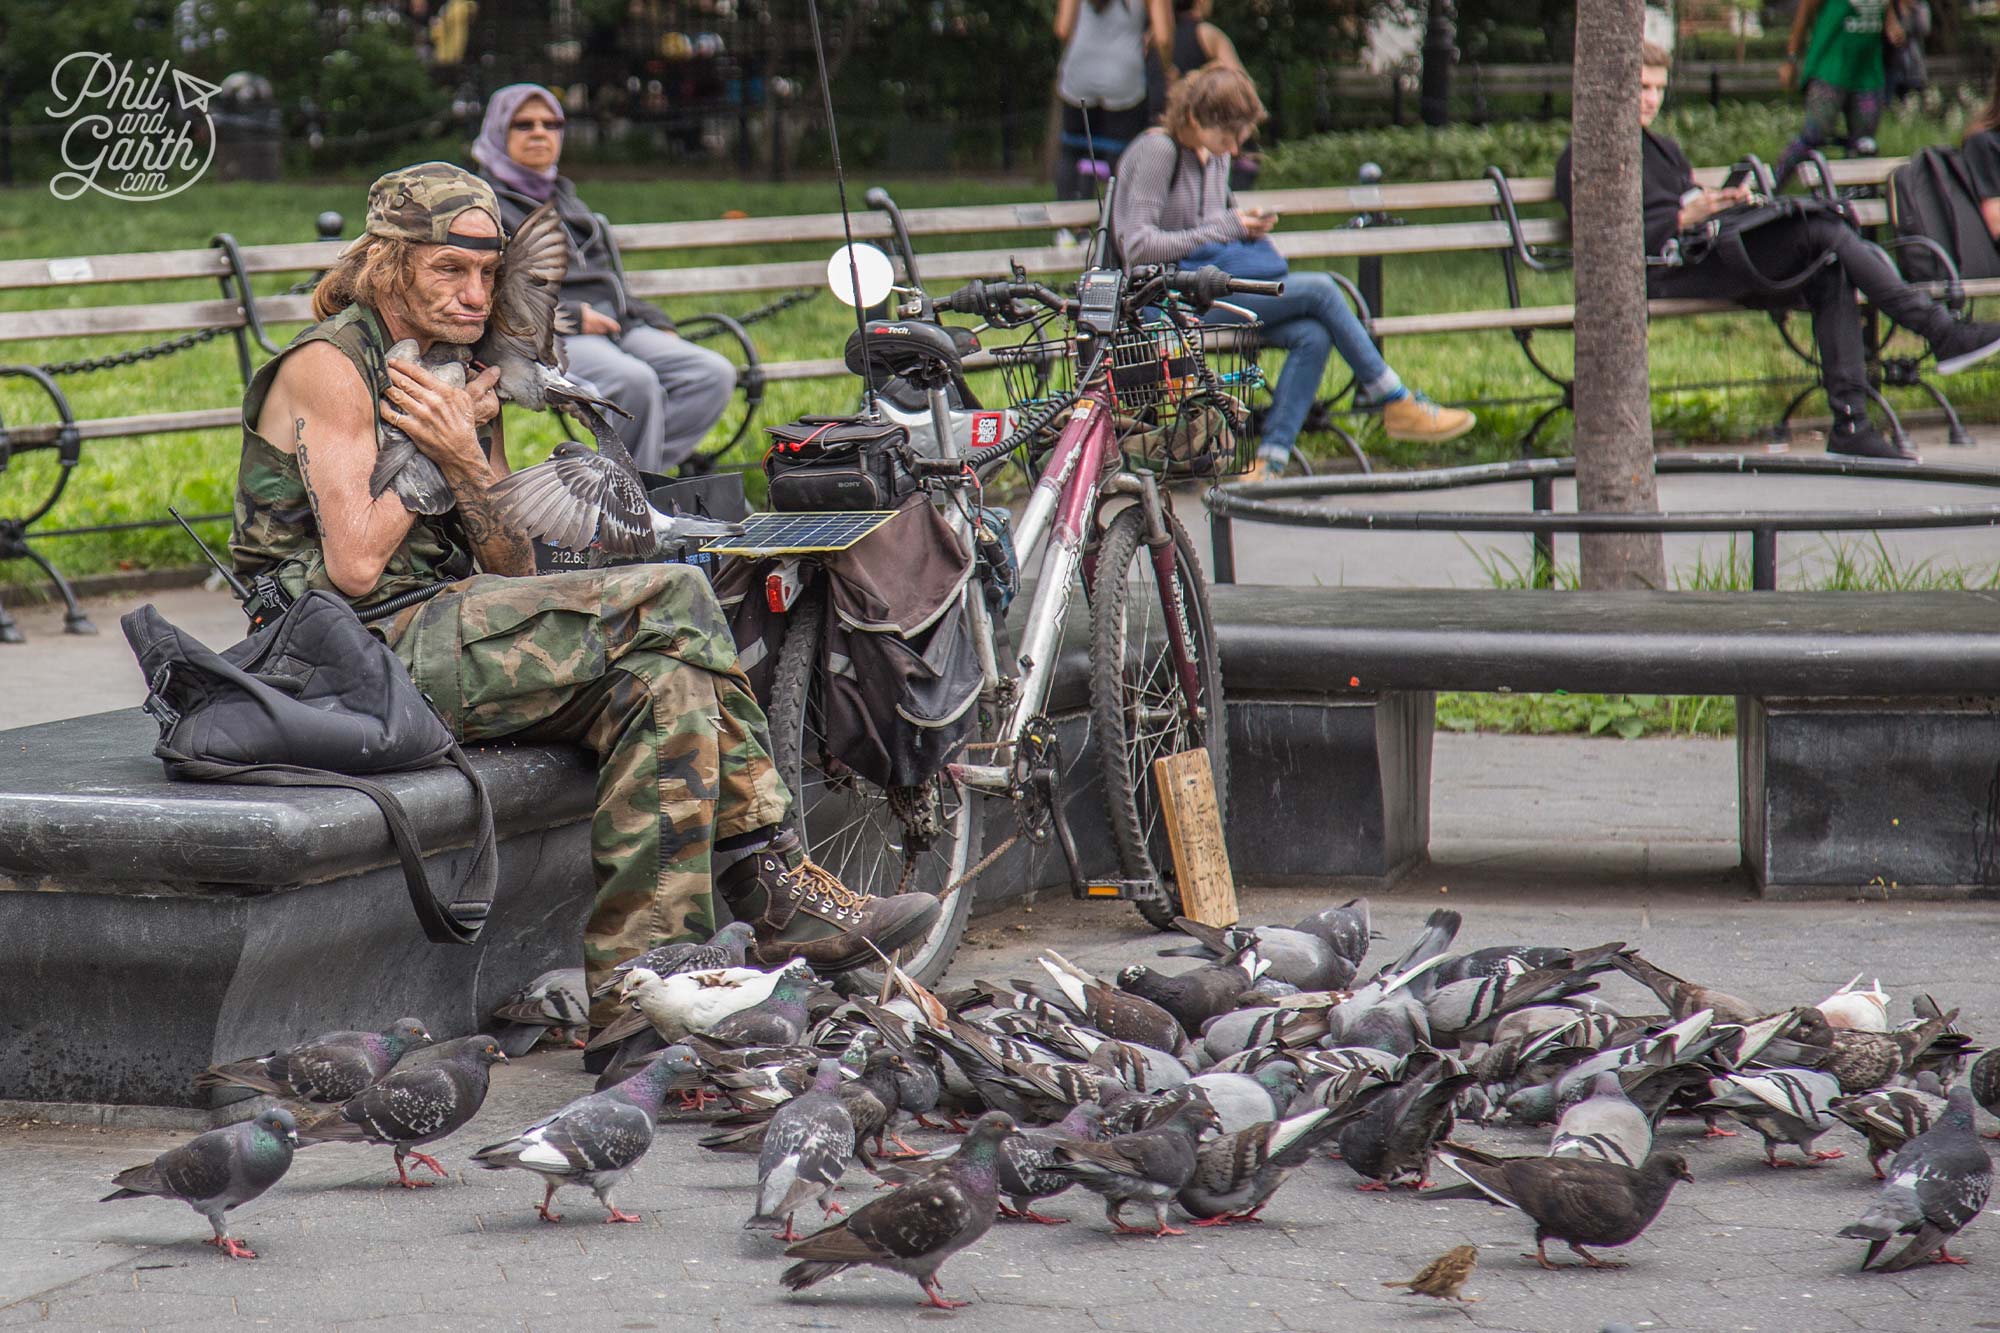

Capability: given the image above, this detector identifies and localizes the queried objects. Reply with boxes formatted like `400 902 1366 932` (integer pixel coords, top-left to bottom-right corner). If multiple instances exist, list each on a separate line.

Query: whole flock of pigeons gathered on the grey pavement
108 899 2000 1309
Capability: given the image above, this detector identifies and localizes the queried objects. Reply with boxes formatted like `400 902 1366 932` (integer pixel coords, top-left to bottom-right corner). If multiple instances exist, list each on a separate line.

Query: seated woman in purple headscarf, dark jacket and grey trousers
472 84 736 472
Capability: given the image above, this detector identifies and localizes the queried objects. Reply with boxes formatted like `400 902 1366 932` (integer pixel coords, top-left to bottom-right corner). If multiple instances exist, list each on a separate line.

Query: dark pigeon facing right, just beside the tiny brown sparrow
1430 1151 1694 1269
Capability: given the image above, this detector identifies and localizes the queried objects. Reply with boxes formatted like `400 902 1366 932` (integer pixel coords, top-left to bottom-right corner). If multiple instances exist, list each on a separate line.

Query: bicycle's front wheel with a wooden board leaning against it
1090 504 1230 931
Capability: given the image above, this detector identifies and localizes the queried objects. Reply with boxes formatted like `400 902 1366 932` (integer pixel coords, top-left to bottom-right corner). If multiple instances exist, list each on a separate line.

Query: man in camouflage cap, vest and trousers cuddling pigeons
230 162 938 1025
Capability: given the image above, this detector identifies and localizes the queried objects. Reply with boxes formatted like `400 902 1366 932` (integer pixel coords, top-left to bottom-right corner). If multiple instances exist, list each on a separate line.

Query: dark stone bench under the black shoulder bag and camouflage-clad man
0 709 594 1109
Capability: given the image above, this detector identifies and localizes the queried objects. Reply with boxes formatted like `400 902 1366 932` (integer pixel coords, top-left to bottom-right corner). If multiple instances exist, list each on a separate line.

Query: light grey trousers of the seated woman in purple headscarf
564 320 736 472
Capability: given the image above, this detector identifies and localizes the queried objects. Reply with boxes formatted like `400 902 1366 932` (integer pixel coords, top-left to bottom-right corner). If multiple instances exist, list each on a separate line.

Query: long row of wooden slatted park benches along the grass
0 158 2000 642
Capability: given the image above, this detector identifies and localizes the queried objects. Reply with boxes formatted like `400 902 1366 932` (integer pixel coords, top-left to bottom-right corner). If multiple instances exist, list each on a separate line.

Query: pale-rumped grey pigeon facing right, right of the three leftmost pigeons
472 1053 678 1223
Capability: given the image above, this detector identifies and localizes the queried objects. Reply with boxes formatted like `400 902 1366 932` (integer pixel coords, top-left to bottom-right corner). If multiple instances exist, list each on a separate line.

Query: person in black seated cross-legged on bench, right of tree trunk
1556 42 2000 458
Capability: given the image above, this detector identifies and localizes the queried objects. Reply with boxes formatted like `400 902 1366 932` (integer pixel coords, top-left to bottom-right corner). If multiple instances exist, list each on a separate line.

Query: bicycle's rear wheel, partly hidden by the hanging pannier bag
770 582 980 991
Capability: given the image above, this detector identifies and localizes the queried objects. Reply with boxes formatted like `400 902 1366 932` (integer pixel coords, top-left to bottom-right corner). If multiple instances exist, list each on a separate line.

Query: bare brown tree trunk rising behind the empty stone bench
1570 0 1666 588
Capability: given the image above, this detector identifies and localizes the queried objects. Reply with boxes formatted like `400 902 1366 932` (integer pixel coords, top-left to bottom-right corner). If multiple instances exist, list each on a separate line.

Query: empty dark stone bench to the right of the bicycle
1168 586 2000 899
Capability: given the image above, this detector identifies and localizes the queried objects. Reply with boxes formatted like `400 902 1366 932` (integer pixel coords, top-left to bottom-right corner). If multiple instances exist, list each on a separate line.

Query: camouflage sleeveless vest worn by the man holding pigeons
230 302 486 610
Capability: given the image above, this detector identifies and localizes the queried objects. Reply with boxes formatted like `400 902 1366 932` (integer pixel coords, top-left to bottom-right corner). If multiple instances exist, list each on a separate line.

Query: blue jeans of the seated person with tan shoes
1206 272 1402 456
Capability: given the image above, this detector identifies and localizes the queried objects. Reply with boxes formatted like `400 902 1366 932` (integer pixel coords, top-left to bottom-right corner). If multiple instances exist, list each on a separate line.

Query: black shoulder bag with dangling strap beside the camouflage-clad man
120 588 498 945
